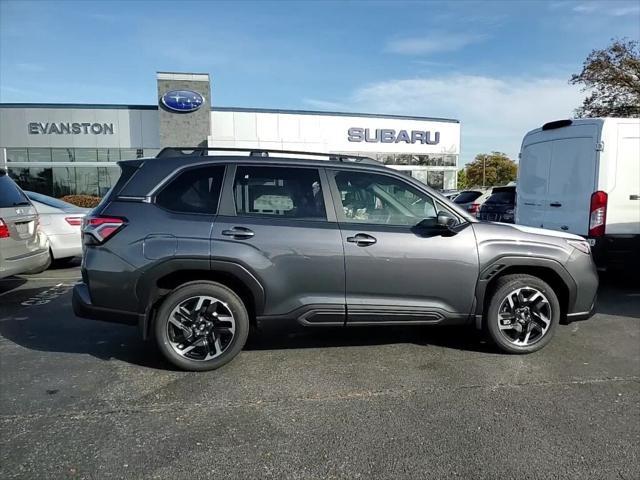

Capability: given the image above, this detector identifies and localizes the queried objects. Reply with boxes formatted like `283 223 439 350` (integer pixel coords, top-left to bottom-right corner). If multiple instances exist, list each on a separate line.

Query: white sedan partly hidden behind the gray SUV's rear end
24 191 91 264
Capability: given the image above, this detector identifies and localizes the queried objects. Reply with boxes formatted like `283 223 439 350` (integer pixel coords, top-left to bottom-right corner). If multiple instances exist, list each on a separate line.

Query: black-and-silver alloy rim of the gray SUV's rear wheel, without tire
167 296 236 361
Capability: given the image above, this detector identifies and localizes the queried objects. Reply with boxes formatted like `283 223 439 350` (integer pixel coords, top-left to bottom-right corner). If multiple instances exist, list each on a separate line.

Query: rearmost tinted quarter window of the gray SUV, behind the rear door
156 165 224 214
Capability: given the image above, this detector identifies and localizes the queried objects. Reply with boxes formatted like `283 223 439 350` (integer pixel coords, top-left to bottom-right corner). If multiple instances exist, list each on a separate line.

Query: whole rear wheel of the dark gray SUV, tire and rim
154 281 249 371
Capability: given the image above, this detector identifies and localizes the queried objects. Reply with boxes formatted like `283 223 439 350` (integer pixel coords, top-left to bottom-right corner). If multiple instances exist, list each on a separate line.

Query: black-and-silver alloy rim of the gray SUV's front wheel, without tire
497 287 553 347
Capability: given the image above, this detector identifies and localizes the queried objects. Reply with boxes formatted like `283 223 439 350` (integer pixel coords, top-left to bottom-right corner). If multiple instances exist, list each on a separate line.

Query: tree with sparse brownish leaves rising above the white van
569 39 640 117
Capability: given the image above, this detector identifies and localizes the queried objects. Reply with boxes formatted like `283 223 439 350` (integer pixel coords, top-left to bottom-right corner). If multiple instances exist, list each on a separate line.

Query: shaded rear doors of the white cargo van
516 122 601 236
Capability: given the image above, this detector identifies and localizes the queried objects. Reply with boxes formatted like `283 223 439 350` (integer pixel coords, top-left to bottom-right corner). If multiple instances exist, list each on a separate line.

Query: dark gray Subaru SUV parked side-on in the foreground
73 149 598 370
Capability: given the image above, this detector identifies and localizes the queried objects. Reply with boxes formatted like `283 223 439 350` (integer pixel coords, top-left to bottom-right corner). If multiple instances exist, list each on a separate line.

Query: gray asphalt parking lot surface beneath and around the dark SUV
0 266 640 479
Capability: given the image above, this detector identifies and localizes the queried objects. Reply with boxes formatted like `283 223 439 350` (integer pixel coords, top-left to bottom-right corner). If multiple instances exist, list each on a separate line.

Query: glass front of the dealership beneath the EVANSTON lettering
6 147 159 198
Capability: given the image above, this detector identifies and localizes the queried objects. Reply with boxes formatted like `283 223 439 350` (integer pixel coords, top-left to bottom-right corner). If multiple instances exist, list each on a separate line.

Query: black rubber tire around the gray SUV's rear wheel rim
153 281 249 371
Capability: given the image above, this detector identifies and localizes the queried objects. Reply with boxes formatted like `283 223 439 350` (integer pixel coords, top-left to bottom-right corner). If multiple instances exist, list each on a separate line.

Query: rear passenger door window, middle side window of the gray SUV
234 166 327 220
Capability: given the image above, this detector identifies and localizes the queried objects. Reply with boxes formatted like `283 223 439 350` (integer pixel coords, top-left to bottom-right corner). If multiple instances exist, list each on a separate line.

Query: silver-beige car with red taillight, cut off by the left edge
0 169 50 278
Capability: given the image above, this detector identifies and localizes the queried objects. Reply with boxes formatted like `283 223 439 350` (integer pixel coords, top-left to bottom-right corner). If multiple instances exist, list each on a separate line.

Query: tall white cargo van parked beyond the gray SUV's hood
516 118 640 268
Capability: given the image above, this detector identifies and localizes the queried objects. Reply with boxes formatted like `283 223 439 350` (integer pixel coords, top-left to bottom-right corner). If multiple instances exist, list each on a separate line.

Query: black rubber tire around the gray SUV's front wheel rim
484 274 560 353
